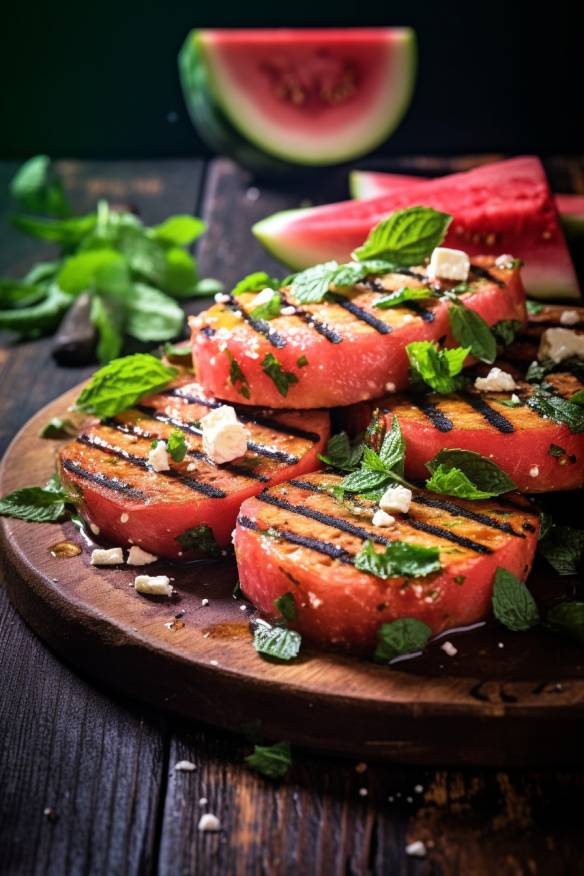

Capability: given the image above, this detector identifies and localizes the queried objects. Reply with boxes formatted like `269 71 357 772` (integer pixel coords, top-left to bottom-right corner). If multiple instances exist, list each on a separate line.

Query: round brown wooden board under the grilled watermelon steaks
0 390 584 765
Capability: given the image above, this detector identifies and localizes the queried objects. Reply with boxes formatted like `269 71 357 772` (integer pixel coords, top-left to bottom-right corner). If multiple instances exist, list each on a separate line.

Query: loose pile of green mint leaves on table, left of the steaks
0 155 221 364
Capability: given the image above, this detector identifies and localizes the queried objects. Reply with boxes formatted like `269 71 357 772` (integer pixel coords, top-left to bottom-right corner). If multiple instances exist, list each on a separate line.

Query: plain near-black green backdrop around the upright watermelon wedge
0 0 584 158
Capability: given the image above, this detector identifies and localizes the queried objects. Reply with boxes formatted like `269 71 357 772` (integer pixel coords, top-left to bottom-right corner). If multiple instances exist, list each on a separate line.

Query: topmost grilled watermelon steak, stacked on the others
191 257 525 408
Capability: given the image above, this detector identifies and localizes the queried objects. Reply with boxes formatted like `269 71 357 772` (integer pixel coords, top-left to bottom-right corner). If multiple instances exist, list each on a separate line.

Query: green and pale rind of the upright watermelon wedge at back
179 29 417 172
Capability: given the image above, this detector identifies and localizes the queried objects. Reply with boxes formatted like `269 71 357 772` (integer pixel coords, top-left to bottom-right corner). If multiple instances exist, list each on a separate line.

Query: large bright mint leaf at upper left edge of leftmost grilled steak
75 353 177 418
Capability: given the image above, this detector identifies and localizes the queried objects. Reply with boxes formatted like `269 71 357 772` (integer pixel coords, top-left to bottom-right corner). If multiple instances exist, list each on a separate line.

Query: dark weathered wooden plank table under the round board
0 159 584 876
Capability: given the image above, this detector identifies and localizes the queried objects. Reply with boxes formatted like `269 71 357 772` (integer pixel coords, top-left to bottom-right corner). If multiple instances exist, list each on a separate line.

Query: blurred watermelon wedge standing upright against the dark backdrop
179 28 416 167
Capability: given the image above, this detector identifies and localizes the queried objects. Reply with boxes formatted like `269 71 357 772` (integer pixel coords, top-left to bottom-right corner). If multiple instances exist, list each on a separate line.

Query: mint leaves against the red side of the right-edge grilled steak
426 449 517 499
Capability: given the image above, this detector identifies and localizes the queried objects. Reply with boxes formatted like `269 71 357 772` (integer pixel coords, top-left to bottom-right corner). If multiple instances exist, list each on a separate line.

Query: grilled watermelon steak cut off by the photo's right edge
343 363 584 493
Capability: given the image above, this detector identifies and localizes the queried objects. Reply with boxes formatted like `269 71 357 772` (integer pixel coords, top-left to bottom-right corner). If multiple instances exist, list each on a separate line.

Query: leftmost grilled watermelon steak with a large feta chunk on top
60 383 329 560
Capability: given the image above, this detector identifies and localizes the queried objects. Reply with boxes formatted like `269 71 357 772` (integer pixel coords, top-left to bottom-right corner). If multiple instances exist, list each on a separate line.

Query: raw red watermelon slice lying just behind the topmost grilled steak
253 156 580 298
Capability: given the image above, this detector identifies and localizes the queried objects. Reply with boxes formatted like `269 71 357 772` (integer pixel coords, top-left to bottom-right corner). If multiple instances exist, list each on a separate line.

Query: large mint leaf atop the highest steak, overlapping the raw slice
353 207 452 266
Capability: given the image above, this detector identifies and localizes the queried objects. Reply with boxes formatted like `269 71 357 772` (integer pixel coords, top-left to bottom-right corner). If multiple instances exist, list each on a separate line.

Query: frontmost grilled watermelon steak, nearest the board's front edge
234 473 538 654
